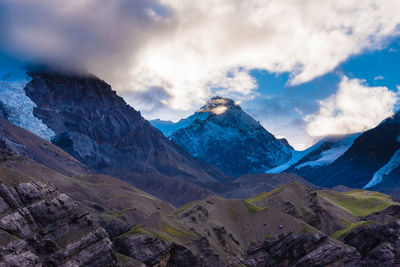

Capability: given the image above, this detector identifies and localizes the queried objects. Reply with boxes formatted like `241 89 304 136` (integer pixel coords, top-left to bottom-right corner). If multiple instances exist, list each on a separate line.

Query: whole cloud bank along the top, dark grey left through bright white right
0 0 400 119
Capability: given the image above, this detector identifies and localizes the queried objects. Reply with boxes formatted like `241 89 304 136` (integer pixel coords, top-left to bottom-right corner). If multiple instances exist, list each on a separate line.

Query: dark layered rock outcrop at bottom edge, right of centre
246 233 361 266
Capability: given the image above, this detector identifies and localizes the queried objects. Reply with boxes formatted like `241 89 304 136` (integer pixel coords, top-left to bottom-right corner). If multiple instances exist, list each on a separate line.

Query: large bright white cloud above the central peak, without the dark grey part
122 0 400 119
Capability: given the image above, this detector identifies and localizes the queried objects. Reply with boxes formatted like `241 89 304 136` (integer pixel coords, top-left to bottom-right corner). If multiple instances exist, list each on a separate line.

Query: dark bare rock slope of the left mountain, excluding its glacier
25 73 228 181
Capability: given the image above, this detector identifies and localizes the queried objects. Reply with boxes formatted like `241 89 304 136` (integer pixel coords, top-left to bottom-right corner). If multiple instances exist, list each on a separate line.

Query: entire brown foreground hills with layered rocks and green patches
0 120 400 266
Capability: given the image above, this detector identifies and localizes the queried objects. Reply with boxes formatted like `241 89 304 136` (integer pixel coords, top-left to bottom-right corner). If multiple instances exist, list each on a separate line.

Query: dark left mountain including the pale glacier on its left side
0 72 231 205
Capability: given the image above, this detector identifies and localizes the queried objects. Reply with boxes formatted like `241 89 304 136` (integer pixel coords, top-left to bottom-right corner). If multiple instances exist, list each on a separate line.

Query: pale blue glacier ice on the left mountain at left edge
0 77 55 141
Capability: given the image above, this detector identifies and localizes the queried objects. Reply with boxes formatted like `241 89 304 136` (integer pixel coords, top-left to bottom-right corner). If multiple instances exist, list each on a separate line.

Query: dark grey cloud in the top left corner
0 0 168 72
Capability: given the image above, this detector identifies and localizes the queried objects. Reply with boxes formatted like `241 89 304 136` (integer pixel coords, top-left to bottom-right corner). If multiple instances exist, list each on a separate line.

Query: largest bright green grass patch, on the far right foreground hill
318 190 398 217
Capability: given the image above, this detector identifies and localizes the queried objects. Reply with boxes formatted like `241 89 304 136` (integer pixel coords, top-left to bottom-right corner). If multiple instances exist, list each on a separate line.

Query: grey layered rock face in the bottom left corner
0 182 117 266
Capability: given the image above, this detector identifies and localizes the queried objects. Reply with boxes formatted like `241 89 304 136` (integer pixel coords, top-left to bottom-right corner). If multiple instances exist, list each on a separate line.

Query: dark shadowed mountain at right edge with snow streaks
269 113 400 197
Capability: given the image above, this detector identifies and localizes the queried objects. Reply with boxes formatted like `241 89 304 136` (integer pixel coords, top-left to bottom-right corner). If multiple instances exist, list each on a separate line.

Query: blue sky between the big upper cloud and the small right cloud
241 38 400 149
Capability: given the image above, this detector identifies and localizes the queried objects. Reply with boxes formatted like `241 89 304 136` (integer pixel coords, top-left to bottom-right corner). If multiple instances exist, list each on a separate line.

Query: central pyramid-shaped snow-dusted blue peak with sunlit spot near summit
153 97 291 176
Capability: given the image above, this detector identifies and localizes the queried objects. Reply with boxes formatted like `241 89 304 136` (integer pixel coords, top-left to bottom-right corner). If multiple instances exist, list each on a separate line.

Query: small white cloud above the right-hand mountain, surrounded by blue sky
305 76 398 136
